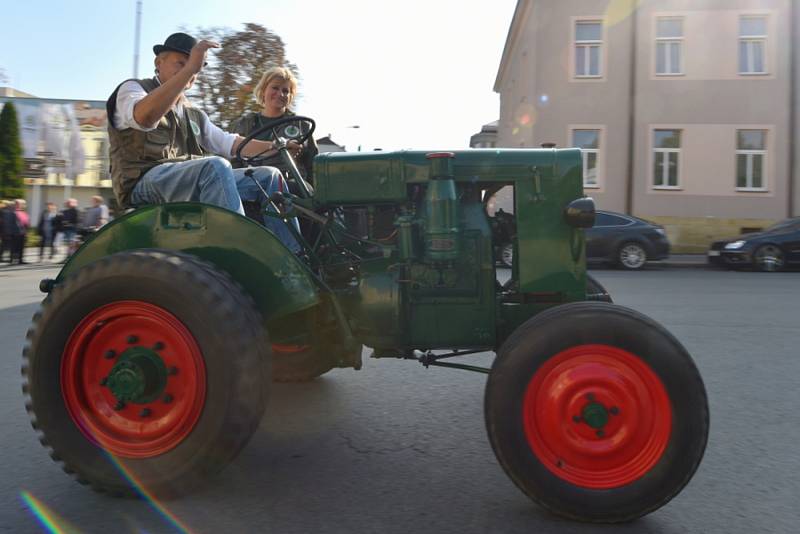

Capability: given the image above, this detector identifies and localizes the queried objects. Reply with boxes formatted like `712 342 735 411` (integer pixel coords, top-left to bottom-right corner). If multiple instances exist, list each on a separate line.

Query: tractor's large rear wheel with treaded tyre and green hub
23 251 269 497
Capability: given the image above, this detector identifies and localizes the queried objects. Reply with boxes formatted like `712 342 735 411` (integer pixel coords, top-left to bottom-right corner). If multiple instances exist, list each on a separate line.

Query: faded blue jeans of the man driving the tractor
131 156 300 252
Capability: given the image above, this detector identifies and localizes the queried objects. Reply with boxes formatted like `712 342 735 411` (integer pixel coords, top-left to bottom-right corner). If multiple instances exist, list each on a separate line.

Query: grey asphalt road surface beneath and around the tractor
0 267 800 534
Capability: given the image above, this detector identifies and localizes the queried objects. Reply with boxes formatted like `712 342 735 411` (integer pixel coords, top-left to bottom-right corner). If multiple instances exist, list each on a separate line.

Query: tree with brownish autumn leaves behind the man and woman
190 22 297 128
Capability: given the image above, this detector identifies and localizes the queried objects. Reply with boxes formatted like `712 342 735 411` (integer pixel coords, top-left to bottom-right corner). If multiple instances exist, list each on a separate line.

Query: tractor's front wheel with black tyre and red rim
485 302 709 523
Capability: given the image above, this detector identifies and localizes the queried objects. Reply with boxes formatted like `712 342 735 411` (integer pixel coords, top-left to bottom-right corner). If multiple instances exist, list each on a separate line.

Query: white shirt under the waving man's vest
114 76 238 157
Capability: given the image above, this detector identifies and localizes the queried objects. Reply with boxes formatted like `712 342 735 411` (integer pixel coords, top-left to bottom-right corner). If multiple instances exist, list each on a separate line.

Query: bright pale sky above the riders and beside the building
0 0 516 150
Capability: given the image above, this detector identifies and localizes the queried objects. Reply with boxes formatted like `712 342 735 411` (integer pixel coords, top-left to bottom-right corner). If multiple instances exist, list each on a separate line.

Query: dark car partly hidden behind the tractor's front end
491 210 670 270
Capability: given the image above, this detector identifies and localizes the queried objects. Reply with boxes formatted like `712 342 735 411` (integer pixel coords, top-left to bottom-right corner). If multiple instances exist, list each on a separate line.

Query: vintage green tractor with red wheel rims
23 117 709 523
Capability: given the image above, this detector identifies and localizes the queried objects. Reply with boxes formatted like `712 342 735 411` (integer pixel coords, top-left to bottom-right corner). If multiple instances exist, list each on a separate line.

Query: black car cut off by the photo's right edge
708 217 800 271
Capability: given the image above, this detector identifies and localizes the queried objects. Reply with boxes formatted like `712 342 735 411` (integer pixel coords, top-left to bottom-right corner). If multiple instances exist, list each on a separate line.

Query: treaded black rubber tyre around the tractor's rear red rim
22 250 270 498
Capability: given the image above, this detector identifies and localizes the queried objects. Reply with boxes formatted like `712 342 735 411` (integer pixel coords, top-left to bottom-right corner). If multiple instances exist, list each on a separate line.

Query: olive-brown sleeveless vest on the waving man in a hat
106 79 203 208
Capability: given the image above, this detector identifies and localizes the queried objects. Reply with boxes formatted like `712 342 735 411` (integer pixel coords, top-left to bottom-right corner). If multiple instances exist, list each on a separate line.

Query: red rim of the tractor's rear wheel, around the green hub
61 301 206 458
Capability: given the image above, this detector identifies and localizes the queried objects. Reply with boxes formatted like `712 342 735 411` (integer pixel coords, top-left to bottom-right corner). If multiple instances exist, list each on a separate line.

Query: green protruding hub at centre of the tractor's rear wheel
107 347 167 404
